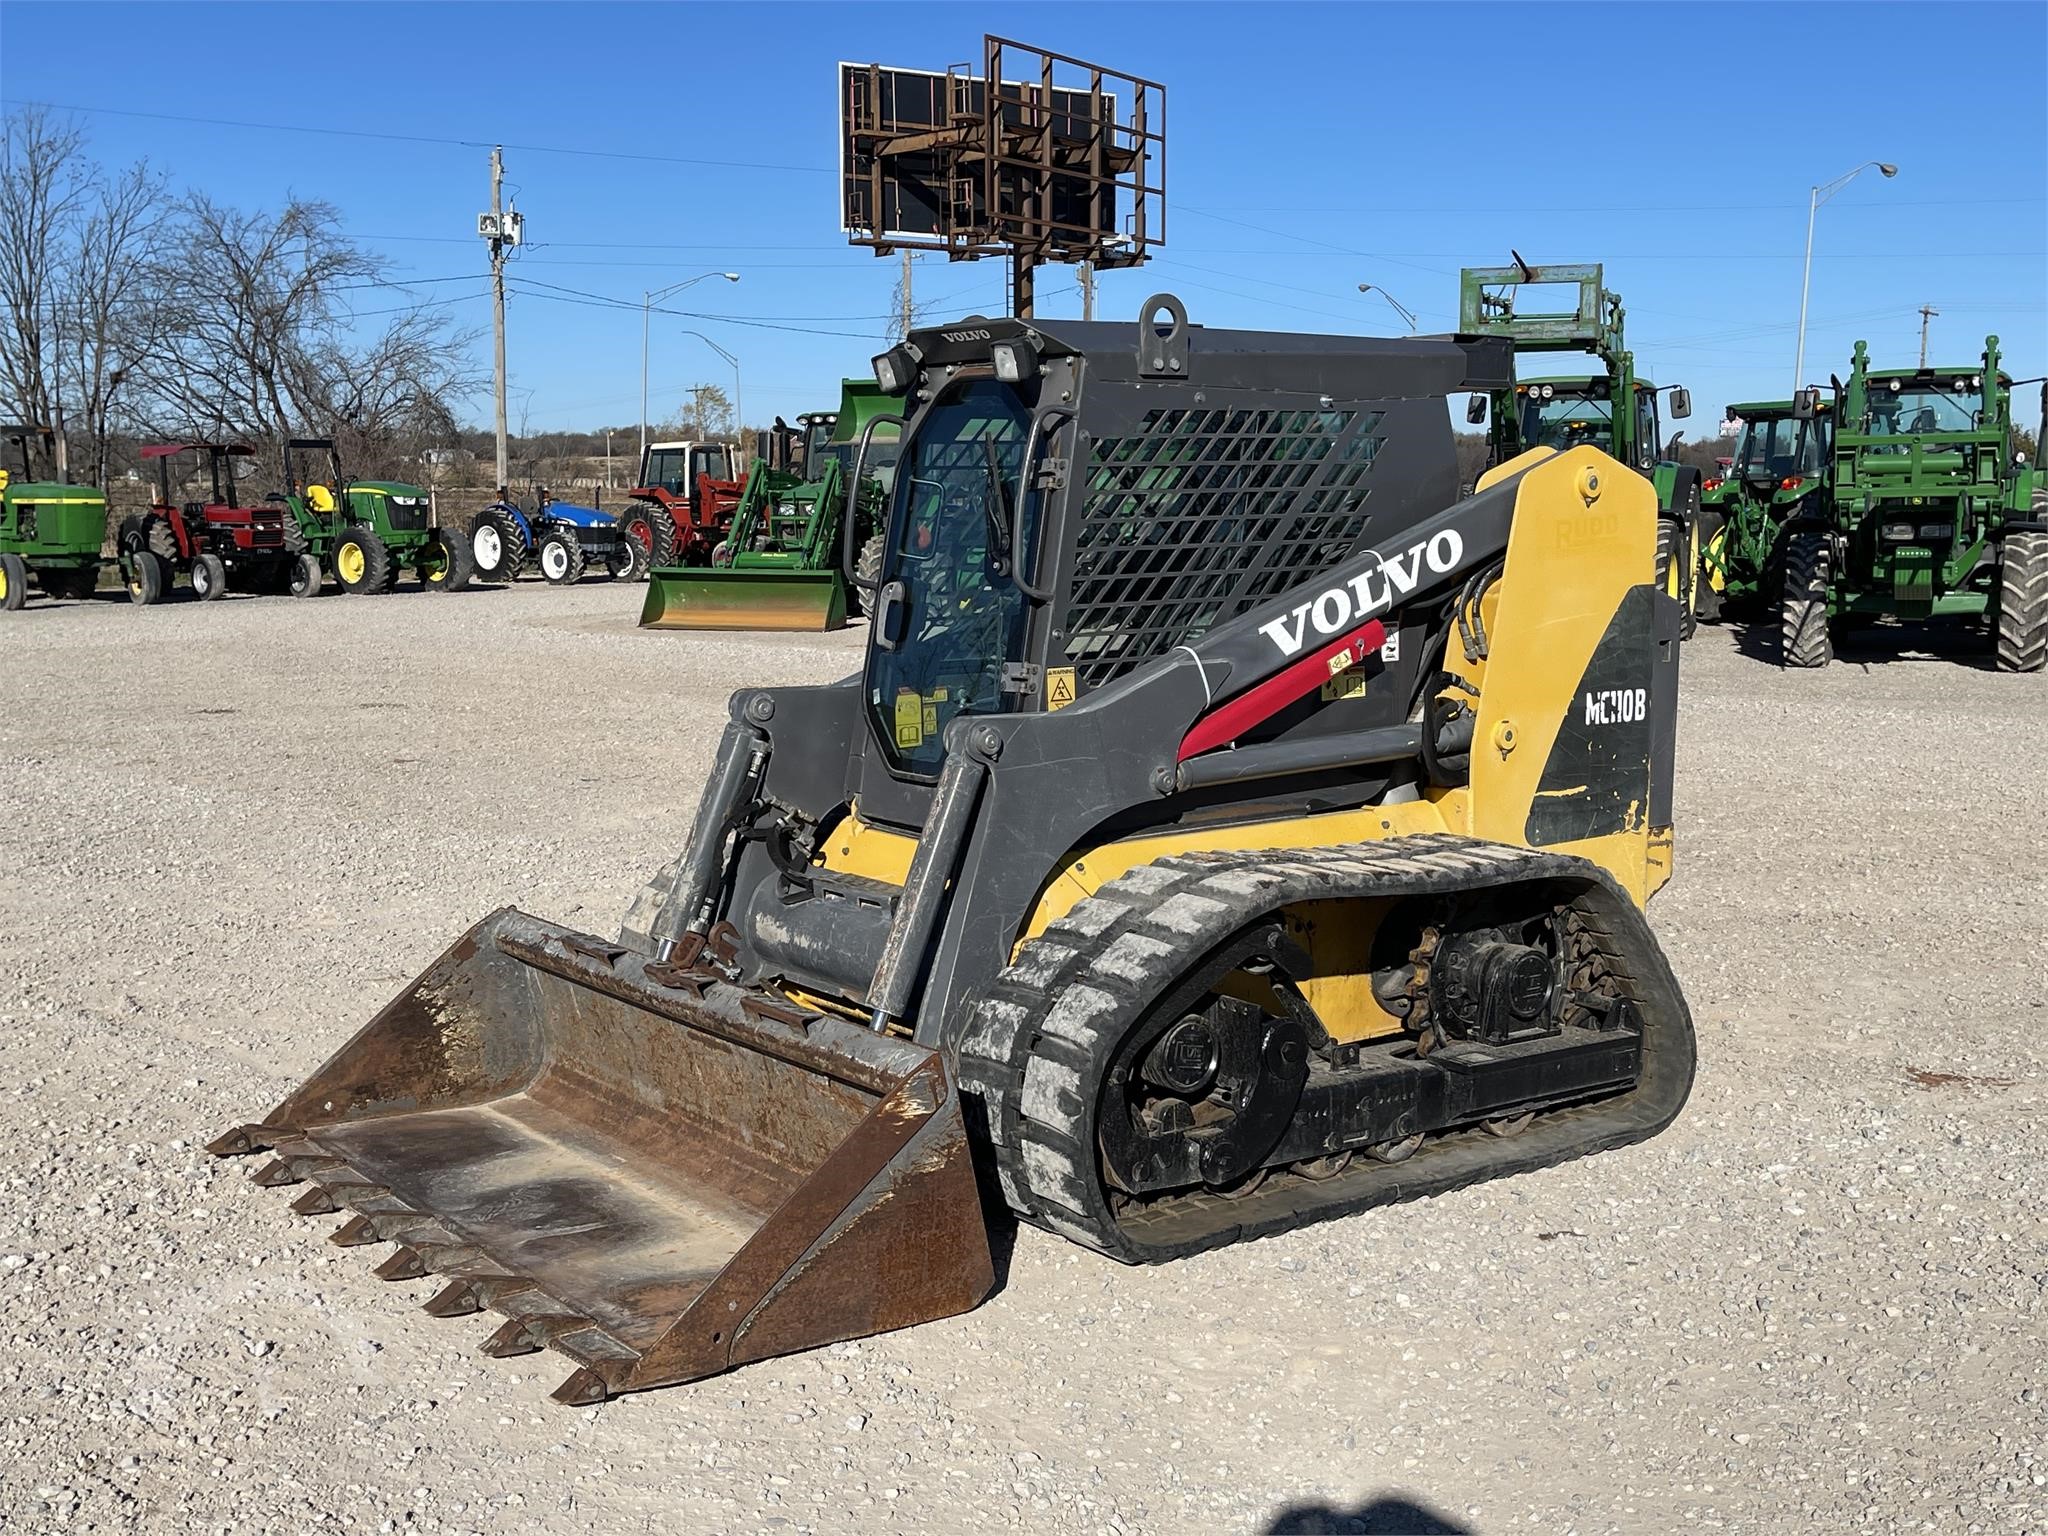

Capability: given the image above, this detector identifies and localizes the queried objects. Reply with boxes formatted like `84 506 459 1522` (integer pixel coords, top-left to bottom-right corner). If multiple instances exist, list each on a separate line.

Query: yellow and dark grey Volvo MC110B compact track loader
213 297 1694 1403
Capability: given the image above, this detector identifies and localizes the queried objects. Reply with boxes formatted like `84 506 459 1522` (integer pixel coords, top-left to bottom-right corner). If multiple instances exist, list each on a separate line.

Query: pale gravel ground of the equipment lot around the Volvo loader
0 584 2048 1536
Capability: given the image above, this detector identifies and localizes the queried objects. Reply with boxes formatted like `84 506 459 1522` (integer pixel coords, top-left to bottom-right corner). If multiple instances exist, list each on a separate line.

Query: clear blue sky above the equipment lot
0 0 2048 434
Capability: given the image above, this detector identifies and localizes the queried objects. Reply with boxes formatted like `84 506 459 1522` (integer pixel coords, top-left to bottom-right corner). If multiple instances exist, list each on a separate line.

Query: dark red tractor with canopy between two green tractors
121 442 319 602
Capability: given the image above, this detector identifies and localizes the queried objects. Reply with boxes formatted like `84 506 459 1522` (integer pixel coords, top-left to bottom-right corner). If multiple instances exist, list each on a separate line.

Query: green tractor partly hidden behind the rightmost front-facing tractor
1700 399 1833 618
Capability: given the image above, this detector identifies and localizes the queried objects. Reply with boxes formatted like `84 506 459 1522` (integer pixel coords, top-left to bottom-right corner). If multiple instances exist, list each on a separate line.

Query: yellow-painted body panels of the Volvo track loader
798 449 1671 1040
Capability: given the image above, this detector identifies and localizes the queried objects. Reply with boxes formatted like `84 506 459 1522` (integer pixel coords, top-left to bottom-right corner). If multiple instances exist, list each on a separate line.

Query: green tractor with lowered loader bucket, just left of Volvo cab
641 379 897 629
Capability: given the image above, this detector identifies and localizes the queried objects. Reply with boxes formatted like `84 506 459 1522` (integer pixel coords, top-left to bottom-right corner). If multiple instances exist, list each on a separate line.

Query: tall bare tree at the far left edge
0 106 84 473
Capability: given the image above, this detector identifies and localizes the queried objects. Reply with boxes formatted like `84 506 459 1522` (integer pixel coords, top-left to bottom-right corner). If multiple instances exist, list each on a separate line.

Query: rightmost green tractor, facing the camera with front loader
1780 336 2048 672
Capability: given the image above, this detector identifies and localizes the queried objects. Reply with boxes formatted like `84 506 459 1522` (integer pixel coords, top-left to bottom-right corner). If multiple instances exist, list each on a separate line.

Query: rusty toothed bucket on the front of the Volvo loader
211 907 993 1405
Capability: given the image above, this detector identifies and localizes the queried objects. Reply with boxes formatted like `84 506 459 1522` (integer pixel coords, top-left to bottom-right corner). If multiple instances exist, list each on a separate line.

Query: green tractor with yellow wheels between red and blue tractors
272 438 475 596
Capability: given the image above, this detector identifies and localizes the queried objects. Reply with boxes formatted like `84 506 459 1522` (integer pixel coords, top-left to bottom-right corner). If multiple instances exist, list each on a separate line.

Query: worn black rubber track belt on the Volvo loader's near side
956 836 1694 1264
